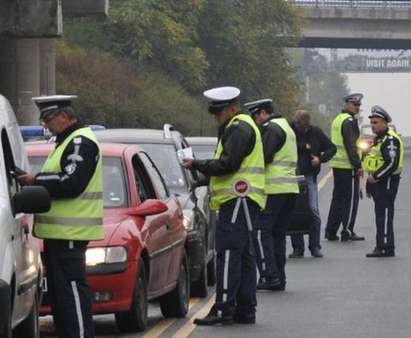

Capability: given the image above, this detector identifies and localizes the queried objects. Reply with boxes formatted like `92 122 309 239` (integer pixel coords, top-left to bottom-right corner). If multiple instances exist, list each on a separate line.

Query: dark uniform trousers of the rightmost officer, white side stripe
369 175 400 253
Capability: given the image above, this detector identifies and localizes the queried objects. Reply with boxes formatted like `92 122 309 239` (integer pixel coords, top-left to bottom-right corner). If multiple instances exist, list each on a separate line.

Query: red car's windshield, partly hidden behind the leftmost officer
29 156 128 208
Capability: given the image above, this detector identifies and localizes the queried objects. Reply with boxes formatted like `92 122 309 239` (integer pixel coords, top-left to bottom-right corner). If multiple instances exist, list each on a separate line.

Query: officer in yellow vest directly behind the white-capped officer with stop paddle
246 99 299 291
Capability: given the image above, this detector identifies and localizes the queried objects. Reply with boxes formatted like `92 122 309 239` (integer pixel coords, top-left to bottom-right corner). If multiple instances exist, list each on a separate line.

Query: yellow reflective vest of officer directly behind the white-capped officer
265 118 299 195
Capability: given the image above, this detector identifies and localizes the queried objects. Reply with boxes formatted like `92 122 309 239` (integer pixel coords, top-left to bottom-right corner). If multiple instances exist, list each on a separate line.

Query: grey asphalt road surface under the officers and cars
41 156 411 338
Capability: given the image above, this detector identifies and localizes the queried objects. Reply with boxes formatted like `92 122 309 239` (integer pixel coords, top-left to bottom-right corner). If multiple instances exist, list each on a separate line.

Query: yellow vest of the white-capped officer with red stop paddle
210 114 265 210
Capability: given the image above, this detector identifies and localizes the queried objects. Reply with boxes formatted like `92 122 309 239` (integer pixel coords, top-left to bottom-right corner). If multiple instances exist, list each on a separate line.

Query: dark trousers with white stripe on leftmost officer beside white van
44 239 94 338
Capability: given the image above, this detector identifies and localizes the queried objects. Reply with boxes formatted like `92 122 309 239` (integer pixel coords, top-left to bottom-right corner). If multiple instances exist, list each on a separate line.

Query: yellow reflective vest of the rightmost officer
363 129 404 175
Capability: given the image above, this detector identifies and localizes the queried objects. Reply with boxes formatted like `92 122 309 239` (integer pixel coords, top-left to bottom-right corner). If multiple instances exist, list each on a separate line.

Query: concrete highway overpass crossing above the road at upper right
289 0 411 49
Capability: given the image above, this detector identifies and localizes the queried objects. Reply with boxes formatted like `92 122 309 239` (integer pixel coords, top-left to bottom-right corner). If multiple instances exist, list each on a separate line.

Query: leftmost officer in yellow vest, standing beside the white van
19 95 104 338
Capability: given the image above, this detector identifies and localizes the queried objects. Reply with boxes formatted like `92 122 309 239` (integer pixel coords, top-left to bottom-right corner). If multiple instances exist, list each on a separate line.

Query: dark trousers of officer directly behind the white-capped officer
265 194 298 284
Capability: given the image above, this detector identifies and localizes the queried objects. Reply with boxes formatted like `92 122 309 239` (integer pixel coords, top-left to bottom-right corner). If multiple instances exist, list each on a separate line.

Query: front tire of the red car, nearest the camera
115 261 148 333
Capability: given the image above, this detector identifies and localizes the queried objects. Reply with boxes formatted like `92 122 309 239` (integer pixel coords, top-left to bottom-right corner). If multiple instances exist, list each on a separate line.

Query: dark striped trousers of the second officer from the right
326 168 360 234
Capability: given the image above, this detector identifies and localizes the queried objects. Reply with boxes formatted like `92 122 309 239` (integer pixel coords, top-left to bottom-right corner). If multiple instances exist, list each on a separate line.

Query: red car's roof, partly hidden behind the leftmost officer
26 143 143 157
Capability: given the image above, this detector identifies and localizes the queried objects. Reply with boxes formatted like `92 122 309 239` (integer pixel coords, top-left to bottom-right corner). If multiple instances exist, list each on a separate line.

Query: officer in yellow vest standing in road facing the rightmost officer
325 94 364 242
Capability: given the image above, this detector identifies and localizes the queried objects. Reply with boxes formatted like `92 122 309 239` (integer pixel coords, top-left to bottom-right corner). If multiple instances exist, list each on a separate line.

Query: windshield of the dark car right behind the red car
141 143 187 193
